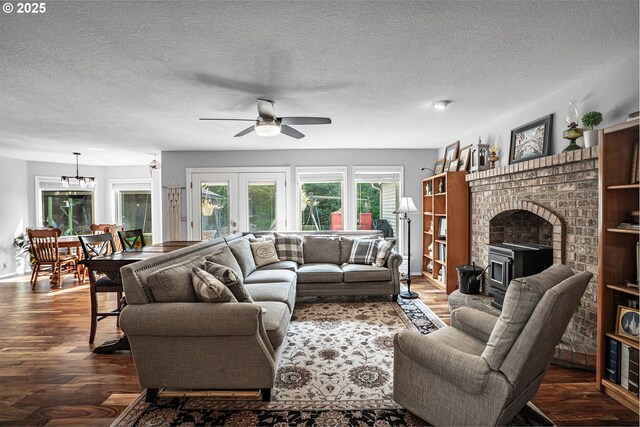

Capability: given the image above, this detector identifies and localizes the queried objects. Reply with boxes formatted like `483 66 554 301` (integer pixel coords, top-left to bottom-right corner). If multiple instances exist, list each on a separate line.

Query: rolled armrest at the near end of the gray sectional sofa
120 302 262 337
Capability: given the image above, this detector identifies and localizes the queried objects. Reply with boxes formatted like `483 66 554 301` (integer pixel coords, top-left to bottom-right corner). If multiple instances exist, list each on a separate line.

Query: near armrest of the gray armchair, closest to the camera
394 331 491 394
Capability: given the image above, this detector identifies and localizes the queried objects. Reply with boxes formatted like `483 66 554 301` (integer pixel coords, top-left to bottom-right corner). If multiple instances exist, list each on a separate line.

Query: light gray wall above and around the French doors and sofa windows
162 149 436 274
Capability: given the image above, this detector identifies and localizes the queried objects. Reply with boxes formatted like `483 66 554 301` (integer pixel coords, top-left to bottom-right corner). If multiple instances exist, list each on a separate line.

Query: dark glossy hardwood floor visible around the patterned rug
0 276 638 426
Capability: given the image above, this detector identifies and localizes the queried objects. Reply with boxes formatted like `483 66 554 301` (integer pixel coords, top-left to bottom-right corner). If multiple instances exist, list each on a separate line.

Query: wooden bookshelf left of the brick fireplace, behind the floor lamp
422 172 469 294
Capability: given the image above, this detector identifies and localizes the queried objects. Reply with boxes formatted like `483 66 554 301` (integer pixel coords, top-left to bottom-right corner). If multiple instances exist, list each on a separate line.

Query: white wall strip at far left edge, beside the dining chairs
0 157 29 277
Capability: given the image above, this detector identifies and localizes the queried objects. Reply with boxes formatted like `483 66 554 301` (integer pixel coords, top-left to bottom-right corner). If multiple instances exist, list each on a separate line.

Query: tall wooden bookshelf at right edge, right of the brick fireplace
596 120 640 413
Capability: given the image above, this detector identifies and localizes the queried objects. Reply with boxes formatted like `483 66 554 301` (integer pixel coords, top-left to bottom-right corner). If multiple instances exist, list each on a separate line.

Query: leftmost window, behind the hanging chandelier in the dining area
36 177 95 235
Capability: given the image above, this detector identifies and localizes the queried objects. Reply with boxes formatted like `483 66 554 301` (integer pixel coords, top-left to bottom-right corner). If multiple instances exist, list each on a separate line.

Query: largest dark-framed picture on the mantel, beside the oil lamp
509 114 553 165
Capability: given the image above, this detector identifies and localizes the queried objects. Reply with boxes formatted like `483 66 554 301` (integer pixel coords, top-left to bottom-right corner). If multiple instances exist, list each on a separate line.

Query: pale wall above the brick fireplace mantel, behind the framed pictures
439 53 639 167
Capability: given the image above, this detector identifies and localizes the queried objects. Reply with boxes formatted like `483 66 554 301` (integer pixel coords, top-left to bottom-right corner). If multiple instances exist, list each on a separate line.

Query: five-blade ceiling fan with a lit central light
200 99 331 139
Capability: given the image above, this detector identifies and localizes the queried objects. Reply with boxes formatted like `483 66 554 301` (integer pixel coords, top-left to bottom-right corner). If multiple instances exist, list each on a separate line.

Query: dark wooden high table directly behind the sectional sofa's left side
83 240 200 354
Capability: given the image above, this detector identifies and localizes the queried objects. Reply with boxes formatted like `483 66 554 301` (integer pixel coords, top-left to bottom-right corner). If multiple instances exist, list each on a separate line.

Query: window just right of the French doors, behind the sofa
296 167 346 230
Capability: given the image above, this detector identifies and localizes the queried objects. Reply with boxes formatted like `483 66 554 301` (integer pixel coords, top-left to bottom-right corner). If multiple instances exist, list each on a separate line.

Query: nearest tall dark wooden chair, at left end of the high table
78 232 123 344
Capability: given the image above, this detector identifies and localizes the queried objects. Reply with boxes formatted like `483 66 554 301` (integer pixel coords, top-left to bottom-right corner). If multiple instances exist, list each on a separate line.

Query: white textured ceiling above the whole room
0 0 638 165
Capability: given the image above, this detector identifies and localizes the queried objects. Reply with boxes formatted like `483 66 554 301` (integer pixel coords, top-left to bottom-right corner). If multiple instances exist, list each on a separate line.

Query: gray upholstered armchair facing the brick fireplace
393 264 592 425
